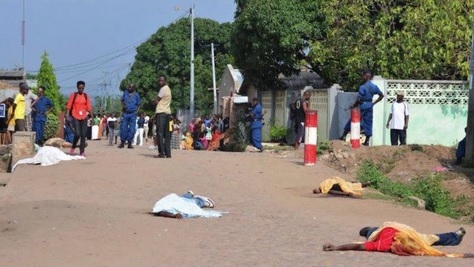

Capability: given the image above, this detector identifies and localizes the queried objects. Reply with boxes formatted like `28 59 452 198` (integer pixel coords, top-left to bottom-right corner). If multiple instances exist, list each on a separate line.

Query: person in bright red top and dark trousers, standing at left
66 81 93 157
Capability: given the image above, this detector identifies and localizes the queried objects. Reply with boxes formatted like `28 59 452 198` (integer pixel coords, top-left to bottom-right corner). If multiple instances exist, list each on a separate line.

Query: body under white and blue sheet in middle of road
152 193 222 219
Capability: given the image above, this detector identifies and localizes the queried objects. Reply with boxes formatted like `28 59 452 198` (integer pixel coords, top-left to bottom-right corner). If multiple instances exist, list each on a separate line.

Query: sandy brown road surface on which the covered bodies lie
0 140 474 266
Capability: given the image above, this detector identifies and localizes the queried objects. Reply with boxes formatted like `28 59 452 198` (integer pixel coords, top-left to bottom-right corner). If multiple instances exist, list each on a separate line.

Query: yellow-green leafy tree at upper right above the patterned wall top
310 0 474 86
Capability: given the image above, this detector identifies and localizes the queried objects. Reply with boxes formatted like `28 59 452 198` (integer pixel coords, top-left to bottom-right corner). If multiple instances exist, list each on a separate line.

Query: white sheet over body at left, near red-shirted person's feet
12 146 85 172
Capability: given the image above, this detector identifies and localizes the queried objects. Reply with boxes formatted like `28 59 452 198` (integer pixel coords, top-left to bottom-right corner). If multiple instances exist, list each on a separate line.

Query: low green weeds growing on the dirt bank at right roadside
357 161 465 218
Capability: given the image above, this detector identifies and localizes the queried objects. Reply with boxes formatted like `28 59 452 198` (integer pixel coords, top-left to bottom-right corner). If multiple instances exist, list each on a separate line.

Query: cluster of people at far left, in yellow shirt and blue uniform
2 82 54 146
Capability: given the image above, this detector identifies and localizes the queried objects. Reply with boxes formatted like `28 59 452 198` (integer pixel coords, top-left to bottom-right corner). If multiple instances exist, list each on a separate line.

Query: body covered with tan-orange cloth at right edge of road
313 176 370 197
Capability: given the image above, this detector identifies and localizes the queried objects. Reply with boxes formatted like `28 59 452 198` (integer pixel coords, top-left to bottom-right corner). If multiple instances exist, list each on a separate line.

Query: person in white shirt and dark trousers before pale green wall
386 91 410 146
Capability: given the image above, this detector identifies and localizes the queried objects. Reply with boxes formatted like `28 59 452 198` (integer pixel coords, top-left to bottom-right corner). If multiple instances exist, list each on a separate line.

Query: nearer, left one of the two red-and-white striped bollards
304 110 318 166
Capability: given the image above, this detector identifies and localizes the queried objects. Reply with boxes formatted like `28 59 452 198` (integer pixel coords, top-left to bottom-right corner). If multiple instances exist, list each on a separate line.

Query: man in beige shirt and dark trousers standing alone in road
155 76 171 158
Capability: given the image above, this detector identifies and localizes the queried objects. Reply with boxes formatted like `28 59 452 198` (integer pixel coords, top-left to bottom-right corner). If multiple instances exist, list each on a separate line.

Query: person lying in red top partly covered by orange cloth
323 222 474 258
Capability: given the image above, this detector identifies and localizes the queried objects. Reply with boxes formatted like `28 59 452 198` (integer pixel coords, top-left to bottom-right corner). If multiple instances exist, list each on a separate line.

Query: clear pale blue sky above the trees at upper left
0 0 236 96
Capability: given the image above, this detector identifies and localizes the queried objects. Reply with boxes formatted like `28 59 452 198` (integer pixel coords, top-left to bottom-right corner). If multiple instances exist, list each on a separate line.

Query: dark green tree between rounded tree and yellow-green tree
233 0 313 88
